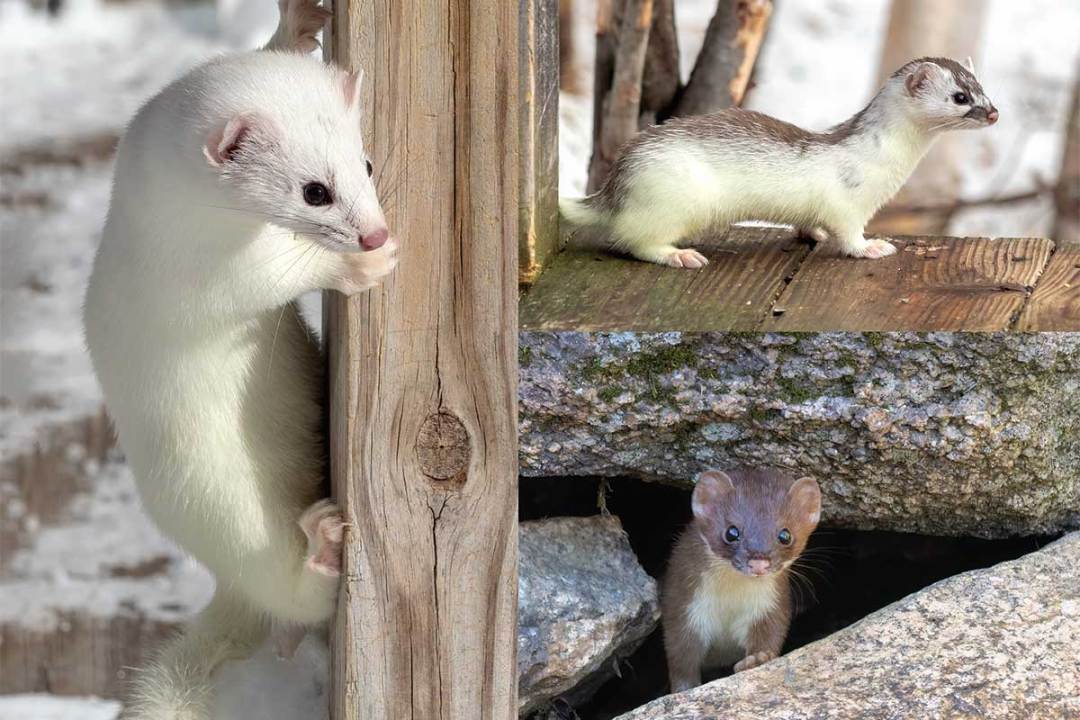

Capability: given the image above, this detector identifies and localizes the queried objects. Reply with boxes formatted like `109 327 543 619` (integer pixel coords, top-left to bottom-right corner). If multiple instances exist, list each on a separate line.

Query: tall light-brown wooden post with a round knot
326 0 519 720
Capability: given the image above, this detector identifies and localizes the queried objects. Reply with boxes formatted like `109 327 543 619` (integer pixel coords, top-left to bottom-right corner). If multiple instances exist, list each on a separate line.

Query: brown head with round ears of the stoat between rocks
691 471 821 576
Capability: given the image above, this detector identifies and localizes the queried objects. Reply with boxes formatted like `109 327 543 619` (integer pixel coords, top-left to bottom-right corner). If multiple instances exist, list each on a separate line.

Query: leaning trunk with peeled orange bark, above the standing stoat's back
672 0 772 117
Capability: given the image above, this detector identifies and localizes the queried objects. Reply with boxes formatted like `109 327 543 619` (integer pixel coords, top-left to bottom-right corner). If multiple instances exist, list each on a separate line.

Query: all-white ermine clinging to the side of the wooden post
85 0 395 720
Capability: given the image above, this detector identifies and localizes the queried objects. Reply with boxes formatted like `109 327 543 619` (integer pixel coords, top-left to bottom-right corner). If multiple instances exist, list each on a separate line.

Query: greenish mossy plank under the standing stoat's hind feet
521 228 810 332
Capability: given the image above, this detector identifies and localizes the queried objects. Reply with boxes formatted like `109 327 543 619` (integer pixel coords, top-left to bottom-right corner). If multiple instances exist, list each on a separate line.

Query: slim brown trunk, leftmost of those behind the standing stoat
586 0 652 192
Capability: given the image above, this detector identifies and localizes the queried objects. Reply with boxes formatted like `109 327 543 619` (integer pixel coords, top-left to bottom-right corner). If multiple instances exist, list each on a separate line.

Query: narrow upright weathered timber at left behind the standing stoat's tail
517 0 559 285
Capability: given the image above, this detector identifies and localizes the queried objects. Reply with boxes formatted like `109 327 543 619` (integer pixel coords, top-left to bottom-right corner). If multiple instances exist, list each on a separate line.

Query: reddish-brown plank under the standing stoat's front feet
765 237 1054 331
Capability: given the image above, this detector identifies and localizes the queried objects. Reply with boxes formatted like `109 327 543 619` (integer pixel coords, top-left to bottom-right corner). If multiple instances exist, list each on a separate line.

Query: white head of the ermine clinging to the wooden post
203 63 389 250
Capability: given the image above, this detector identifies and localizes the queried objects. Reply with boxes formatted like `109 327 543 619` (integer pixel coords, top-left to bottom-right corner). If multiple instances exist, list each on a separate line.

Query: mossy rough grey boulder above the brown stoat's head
518 332 1080 536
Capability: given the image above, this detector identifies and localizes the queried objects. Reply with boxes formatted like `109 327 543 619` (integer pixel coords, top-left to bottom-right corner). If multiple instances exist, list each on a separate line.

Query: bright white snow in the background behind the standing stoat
559 0 1080 236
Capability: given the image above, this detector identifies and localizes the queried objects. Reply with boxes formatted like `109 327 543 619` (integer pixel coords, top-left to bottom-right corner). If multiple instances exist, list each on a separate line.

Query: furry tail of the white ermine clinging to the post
121 588 269 720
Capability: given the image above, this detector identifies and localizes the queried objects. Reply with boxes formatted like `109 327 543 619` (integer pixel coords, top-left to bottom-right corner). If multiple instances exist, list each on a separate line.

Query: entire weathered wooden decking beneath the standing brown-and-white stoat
521 228 1062 331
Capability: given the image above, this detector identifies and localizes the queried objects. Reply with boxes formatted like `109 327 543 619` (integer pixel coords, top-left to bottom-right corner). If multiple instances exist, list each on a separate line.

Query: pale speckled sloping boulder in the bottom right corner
620 533 1080 720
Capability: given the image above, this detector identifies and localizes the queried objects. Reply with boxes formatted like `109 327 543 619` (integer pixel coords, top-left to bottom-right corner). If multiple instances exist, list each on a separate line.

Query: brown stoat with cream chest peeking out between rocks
660 470 821 692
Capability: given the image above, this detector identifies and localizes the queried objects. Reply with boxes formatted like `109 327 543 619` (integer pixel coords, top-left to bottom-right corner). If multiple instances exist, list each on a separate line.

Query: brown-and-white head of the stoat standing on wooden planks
890 57 998 131
